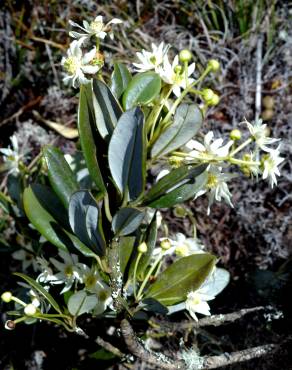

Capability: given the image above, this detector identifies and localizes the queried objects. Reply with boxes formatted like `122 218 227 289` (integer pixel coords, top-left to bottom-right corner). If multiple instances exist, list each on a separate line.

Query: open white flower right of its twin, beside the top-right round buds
157 55 195 97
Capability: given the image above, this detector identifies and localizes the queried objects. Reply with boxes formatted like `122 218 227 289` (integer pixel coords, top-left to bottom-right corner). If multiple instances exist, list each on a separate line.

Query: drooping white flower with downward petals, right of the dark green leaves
195 166 234 215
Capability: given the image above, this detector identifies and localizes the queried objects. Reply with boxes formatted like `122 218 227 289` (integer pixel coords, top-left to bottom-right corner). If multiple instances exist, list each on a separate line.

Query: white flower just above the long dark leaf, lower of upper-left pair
61 40 101 88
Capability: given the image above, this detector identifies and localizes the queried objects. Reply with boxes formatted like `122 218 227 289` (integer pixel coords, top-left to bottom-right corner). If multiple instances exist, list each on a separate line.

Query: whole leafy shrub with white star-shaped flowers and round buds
1 16 284 366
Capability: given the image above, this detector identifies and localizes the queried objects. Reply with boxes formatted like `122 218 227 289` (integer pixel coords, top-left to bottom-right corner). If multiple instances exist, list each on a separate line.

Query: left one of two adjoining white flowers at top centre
133 42 170 72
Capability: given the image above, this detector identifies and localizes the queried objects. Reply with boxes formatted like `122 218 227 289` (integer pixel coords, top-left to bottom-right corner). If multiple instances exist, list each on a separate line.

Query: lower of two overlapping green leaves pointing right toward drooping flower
147 172 208 208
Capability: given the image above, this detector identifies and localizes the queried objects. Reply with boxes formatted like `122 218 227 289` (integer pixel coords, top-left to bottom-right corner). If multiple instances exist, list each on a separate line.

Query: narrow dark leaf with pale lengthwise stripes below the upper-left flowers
92 80 123 140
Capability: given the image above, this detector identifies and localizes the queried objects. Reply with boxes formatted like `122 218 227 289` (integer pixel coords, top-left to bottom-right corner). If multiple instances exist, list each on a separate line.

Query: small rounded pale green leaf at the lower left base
68 290 98 316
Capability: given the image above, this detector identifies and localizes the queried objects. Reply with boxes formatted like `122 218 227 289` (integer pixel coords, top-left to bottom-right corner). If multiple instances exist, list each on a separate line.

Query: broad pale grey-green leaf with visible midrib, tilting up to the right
151 104 203 157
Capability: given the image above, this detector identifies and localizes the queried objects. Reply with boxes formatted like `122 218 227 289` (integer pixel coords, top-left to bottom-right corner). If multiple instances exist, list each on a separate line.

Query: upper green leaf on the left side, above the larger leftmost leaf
43 146 79 208
